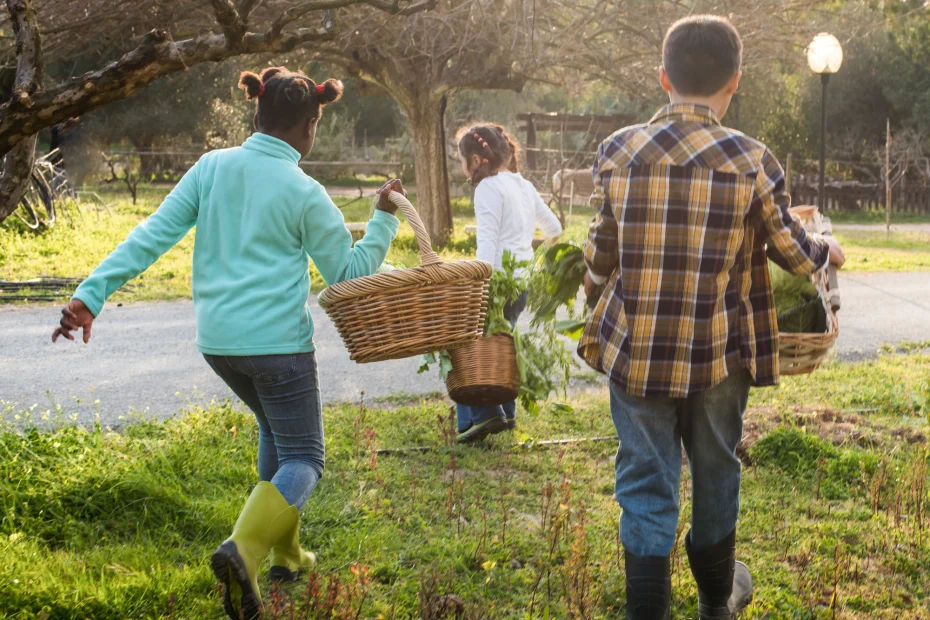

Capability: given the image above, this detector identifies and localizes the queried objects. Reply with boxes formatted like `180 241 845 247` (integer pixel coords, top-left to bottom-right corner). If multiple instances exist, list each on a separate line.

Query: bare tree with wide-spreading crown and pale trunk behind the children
306 0 852 243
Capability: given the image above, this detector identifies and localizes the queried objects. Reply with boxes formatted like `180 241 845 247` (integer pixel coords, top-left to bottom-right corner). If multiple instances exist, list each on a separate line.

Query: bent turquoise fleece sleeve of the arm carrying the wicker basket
300 186 400 286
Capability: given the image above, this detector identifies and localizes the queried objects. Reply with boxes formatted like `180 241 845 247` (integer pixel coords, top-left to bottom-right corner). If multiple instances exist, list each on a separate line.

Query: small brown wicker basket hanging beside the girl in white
446 334 520 407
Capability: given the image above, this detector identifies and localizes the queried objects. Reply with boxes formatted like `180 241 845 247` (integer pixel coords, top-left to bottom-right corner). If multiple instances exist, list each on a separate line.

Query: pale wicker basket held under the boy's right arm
778 206 839 375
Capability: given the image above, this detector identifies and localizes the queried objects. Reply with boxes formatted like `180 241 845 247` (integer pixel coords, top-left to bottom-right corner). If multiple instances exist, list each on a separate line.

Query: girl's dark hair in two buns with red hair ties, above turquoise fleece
239 67 342 131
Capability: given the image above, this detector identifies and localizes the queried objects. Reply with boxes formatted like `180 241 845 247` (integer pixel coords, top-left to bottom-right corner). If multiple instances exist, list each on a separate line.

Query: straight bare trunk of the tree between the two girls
407 95 452 245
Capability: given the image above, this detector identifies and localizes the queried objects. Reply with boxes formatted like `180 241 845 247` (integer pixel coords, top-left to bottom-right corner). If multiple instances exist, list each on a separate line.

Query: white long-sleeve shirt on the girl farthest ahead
475 172 562 270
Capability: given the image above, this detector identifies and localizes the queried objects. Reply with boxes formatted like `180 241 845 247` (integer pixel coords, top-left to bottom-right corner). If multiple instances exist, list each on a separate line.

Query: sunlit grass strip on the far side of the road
0 185 930 303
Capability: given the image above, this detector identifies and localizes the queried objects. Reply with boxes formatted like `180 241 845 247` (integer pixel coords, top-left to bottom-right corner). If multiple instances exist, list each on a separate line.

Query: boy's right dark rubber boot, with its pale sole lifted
685 530 752 620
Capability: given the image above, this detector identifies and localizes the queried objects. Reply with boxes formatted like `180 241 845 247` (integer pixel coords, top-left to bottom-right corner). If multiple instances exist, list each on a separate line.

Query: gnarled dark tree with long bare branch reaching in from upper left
0 0 432 221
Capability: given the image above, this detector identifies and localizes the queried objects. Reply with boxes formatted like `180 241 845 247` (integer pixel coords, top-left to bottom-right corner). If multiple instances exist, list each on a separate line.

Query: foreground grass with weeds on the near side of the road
0 353 930 620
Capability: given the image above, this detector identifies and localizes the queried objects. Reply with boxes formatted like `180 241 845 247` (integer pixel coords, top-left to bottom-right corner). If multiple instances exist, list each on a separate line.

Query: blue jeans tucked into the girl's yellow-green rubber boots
204 353 326 509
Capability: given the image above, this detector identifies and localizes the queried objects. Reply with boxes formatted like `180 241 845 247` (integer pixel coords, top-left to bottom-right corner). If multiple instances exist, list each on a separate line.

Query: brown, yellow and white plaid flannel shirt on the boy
578 105 829 398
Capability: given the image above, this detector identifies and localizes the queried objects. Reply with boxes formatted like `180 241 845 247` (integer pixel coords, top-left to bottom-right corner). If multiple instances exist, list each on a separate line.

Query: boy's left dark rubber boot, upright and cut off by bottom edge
624 551 672 620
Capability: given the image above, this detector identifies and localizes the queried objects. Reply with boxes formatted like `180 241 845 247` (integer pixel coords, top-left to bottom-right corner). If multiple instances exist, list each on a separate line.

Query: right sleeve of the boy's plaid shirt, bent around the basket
749 149 830 274
